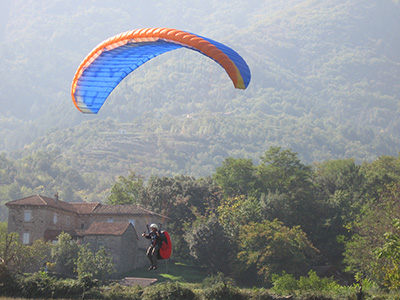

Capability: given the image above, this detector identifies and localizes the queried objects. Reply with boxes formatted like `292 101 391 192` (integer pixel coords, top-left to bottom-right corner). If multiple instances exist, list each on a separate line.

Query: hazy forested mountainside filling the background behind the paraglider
0 0 400 176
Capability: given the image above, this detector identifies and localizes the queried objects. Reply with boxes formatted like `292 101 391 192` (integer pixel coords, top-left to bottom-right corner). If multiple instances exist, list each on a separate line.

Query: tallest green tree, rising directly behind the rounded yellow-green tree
257 147 320 235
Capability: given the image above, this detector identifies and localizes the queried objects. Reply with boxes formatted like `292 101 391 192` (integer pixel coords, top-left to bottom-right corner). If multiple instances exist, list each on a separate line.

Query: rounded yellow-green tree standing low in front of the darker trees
238 220 319 281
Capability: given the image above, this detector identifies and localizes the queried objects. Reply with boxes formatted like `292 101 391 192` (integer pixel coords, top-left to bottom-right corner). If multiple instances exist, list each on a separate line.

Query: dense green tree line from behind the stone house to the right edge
109 147 400 287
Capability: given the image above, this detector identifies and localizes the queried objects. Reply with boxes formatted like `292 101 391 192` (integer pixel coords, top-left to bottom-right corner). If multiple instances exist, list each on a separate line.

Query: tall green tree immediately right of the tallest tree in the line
313 159 367 265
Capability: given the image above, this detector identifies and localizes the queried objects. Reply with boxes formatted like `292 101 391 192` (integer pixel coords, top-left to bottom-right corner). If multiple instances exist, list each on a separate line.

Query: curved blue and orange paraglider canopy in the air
71 28 250 114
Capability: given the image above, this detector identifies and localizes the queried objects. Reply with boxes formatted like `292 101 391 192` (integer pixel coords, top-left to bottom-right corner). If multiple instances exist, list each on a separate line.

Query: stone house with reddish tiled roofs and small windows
6 195 167 274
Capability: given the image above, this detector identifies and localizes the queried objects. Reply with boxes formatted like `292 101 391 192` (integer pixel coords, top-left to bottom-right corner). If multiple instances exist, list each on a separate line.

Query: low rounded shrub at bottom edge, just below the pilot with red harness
142 282 195 300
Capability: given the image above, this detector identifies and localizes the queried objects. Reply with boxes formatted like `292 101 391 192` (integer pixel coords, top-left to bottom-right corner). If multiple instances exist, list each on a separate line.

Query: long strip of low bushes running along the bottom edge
7 271 400 300
